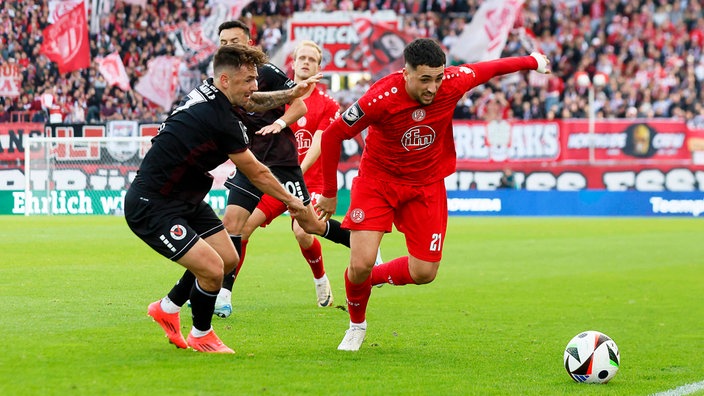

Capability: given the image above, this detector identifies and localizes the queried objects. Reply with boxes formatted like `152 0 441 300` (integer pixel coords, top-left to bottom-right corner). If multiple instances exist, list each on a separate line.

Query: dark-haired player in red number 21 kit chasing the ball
316 39 549 351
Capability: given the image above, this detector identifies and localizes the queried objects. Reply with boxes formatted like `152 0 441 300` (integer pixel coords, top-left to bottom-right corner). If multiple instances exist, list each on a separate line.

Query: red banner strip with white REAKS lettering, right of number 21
454 119 692 165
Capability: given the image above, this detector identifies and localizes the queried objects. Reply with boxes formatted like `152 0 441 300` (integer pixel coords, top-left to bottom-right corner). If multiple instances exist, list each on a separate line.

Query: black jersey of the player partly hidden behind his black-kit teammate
238 63 298 166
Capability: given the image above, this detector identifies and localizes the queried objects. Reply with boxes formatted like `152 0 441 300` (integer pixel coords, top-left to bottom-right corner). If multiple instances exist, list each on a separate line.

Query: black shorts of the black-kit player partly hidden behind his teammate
225 166 310 213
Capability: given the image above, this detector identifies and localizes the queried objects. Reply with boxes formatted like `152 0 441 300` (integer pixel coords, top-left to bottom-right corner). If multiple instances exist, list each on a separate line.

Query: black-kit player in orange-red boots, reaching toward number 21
125 46 307 353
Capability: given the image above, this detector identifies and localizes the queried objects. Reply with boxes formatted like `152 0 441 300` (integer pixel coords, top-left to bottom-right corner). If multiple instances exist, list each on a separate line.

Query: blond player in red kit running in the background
235 41 340 307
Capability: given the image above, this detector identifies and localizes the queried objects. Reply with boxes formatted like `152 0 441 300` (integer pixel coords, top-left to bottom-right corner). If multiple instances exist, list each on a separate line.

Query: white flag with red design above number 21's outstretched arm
450 0 525 63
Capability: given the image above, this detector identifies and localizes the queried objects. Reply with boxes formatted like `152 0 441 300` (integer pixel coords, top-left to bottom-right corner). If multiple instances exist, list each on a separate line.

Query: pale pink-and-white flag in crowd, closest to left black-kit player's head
134 56 181 111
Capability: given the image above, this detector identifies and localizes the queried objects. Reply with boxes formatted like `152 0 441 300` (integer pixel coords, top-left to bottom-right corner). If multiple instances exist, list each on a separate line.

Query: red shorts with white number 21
342 176 447 262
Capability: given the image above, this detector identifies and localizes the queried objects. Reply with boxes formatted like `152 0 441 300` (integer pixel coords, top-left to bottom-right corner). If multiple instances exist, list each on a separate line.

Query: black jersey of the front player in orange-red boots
132 78 249 204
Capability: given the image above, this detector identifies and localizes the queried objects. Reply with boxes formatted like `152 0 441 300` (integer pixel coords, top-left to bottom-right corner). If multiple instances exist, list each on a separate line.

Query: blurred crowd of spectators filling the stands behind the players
0 0 704 127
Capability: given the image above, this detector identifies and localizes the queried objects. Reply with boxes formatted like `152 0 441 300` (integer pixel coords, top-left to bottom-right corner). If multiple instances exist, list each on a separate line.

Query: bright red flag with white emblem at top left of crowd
40 1 90 74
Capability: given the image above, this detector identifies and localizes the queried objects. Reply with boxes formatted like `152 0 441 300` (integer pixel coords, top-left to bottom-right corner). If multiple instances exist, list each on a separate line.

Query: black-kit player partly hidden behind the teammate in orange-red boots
215 21 350 318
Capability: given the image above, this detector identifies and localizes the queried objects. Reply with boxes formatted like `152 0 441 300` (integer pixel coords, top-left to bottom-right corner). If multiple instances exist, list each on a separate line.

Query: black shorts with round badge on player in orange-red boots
125 188 225 261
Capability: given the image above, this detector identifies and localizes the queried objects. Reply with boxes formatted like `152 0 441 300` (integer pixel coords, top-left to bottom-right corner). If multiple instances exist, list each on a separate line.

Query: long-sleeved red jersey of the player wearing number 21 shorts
321 56 538 197
